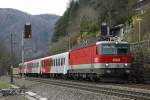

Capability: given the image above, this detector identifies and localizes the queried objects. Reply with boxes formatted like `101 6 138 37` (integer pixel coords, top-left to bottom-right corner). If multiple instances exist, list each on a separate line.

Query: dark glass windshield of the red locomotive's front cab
98 44 129 55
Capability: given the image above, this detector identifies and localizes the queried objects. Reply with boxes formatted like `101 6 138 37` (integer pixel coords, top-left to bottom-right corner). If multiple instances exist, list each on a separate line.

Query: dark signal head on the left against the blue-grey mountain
24 23 32 39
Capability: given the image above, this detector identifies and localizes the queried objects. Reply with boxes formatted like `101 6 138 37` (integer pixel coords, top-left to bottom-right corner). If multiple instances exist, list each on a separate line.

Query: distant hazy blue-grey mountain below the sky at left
0 9 59 58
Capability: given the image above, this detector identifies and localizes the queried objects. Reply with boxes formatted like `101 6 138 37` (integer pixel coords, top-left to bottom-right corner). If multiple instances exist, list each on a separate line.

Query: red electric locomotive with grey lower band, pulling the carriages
68 41 131 80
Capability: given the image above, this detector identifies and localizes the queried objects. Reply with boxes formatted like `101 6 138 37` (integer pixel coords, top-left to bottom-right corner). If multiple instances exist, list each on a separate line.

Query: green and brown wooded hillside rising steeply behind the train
49 0 138 54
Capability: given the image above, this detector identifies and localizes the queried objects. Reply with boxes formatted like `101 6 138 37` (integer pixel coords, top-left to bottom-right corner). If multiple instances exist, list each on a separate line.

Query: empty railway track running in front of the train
23 78 150 100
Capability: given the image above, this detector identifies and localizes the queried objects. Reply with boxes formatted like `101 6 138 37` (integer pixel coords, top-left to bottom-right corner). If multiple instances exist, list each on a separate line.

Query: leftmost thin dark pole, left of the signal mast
10 33 13 83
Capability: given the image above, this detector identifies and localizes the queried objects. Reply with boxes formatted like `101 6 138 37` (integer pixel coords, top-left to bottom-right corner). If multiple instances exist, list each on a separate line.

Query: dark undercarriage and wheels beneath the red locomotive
68 68 130 81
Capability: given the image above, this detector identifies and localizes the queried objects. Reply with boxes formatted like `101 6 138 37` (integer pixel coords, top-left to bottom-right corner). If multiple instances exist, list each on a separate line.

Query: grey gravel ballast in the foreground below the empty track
0 77 130 100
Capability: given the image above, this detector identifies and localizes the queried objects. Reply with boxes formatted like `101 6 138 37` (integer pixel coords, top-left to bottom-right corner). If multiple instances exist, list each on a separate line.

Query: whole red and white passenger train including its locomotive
19 41 131 80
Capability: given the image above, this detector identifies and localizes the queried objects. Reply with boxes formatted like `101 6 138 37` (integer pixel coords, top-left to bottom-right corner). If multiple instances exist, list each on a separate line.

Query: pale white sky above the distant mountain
0 0 69 15
